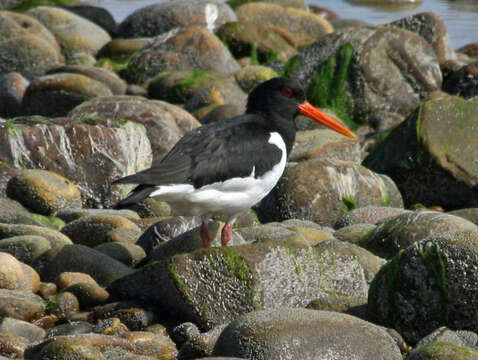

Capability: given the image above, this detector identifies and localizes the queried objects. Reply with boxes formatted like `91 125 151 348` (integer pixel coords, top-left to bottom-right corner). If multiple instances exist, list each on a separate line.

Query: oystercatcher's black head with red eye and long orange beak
247 77 356 138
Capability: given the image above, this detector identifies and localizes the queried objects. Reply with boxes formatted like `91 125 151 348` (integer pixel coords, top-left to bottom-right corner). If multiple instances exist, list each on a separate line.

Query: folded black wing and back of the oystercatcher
114 115 282 188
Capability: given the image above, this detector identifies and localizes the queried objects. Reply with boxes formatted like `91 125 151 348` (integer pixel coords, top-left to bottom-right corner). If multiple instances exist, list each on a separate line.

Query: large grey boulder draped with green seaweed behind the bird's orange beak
284 27 442 131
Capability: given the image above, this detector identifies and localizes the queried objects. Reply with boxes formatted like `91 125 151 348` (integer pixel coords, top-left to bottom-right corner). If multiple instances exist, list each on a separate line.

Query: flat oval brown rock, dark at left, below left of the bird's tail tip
62 215 141 247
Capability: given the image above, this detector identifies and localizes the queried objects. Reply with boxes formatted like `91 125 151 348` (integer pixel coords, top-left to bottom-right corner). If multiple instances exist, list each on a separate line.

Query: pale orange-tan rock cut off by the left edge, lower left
0 252 40 293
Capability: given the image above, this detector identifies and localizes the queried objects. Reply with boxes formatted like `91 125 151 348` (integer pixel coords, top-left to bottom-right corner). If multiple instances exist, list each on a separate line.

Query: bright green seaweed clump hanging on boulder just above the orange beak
306 44 358 130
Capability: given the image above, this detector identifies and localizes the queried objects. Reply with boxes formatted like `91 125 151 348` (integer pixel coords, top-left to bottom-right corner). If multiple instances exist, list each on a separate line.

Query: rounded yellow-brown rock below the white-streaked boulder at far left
7 170 81 215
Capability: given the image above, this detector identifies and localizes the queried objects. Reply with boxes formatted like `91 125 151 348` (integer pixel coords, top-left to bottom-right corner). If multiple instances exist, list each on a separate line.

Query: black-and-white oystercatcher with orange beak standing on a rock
113 78 356 247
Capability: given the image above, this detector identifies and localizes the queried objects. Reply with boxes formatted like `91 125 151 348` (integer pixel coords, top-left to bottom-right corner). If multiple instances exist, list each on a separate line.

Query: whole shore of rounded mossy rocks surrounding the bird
0 0 478 360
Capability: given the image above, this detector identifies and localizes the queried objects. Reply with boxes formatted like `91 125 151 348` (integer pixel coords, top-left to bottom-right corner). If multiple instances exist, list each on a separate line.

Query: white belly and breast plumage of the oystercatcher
150 133 287 216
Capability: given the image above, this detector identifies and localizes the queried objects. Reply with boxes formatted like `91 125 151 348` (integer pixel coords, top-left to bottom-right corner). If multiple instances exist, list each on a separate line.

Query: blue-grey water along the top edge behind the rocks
100 0 478 49
